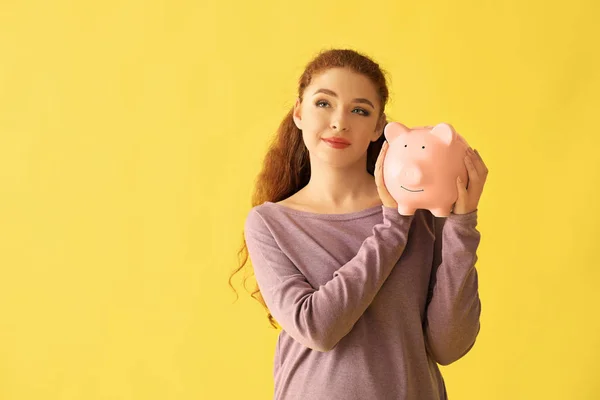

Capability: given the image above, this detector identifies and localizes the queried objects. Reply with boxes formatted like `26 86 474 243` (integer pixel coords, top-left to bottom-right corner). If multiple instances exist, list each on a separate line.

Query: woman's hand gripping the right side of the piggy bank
452 147 488 214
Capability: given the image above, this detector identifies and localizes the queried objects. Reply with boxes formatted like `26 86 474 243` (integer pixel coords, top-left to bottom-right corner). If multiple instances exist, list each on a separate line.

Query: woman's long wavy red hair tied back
229 49 389 329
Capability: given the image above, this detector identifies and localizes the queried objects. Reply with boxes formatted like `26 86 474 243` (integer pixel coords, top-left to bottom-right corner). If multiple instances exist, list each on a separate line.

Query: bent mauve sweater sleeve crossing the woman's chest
244 206 413 352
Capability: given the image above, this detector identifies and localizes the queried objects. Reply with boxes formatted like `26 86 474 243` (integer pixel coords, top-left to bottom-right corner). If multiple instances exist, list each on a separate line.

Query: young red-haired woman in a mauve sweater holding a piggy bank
234 50 488 400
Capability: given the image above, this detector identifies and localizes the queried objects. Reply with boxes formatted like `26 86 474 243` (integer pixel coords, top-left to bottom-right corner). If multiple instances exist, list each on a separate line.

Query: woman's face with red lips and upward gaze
294 68 385 166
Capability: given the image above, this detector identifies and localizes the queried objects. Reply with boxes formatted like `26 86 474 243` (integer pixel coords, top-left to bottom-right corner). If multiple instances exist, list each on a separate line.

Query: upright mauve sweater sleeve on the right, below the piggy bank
425 210 481 365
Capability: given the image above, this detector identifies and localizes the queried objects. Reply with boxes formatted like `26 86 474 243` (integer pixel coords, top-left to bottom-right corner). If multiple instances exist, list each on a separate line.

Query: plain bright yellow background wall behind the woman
0 0 600 400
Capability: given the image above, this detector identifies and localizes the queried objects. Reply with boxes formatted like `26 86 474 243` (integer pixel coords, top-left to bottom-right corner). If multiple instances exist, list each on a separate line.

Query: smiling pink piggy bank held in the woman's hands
383 122 469 217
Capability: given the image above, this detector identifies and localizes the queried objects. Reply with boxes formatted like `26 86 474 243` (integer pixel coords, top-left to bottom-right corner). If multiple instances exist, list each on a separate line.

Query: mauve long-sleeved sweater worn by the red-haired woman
244 202 481 400
